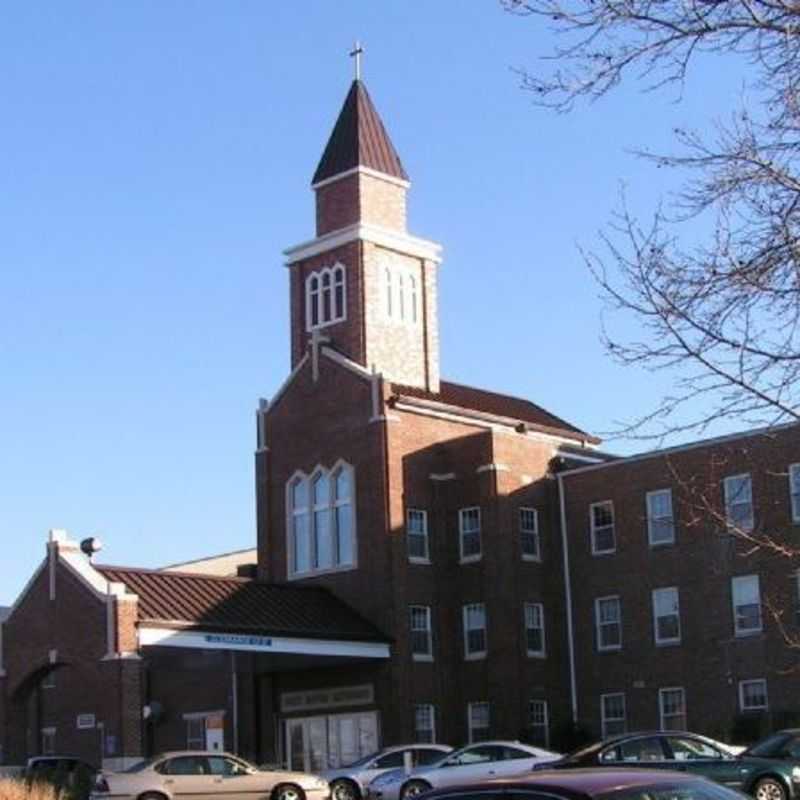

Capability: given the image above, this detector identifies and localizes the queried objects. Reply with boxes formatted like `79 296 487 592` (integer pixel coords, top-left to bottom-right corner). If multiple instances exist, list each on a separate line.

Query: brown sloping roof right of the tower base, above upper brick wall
392 381 600 443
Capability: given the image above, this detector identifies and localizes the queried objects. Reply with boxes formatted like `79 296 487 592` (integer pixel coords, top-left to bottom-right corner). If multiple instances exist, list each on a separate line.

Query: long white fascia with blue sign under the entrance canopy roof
139 627 391 659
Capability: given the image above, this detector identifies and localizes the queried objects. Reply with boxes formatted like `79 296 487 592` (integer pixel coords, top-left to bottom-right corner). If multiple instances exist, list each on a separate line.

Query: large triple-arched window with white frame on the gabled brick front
286 463 355 575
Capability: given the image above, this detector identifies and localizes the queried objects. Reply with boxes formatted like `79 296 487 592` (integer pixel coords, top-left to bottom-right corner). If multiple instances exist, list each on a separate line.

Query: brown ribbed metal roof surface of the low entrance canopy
97 566 388 642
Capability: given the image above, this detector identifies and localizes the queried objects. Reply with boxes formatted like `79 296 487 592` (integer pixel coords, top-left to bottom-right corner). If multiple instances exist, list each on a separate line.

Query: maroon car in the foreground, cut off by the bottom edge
418 768 749 800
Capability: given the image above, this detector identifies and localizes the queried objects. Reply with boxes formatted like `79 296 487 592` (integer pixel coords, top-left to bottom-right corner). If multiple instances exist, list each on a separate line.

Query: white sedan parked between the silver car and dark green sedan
369 742 561 800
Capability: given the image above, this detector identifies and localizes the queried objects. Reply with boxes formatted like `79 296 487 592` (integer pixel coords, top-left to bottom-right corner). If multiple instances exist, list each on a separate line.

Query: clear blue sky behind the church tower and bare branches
0 0 752 604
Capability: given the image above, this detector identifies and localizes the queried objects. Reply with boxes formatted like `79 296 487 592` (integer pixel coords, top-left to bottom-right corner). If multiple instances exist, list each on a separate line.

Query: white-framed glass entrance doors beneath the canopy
285 711 379 772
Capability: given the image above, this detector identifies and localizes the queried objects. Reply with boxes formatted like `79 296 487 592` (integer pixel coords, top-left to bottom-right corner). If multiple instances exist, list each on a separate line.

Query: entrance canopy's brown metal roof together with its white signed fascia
96 566 390 660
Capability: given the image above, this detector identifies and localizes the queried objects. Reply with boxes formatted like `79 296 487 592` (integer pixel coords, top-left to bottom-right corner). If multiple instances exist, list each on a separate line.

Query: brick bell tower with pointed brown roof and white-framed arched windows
285 77 441 392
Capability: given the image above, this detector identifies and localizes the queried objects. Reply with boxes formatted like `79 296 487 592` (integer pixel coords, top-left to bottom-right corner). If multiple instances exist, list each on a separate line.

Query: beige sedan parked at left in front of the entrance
92 751 330 800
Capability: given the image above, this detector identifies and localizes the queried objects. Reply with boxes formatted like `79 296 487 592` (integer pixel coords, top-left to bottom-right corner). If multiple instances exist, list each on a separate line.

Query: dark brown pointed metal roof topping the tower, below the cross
311 80 408 184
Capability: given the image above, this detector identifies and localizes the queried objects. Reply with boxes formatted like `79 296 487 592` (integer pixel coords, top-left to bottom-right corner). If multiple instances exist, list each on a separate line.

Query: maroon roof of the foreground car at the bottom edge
426 767 720 797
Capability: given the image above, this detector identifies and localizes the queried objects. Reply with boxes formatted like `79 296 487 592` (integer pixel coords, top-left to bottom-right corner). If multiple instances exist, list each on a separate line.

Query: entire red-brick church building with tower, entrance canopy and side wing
0 80 800 771
